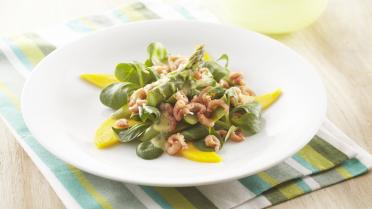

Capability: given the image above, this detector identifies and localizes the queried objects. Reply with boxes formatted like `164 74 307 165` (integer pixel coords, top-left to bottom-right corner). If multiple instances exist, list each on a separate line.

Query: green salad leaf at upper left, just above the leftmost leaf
115 62 157 87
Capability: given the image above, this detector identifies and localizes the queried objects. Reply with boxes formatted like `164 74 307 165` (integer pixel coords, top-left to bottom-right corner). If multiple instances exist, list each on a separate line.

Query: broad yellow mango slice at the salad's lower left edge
94 117 137 149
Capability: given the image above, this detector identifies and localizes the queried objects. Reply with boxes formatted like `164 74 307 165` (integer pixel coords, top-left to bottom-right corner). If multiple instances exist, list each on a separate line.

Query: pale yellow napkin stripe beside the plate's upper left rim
10 36 45 66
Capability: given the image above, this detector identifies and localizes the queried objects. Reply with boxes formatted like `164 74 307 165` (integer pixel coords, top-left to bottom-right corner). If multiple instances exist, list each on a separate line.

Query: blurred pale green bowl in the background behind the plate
205 0 328 34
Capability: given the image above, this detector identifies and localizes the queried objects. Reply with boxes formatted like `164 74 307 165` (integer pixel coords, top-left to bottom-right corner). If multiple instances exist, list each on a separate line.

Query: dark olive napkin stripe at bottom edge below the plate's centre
154 187 196 209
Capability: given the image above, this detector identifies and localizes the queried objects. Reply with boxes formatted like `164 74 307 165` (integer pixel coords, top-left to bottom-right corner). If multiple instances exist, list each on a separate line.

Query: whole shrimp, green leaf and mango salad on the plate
81 42 281 163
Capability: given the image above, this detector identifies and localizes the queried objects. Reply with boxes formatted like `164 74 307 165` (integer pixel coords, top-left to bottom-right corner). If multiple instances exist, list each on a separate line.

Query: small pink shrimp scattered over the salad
128 56 255 155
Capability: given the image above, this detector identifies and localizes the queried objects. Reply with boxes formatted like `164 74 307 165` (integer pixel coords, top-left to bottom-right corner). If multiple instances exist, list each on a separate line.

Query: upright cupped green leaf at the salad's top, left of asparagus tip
145 42 168 67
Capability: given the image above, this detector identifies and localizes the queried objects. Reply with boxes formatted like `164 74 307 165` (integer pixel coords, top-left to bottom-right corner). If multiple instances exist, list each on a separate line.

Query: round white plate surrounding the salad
22 20 326 186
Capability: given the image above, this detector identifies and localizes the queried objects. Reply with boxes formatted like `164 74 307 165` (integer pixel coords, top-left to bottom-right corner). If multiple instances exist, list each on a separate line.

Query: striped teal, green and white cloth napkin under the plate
0 0 372 209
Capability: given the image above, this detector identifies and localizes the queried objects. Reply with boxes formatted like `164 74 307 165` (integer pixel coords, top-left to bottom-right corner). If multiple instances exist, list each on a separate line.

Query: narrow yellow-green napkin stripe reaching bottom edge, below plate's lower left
68 165 113 209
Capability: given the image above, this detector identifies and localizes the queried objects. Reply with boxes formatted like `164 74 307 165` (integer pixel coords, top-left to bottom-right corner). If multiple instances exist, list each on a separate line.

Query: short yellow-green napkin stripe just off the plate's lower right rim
298 146 334 170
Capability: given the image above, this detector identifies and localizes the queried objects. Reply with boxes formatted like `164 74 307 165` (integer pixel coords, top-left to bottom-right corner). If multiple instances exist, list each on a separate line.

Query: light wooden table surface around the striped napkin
0 0 372 209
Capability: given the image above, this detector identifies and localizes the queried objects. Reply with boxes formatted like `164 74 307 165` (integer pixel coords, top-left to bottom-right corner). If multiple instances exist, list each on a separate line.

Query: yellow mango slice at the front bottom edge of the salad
181 143 222 163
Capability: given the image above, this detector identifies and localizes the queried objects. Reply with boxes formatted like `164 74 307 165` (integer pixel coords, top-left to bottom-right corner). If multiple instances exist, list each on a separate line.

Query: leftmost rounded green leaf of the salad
99 82 138 110
